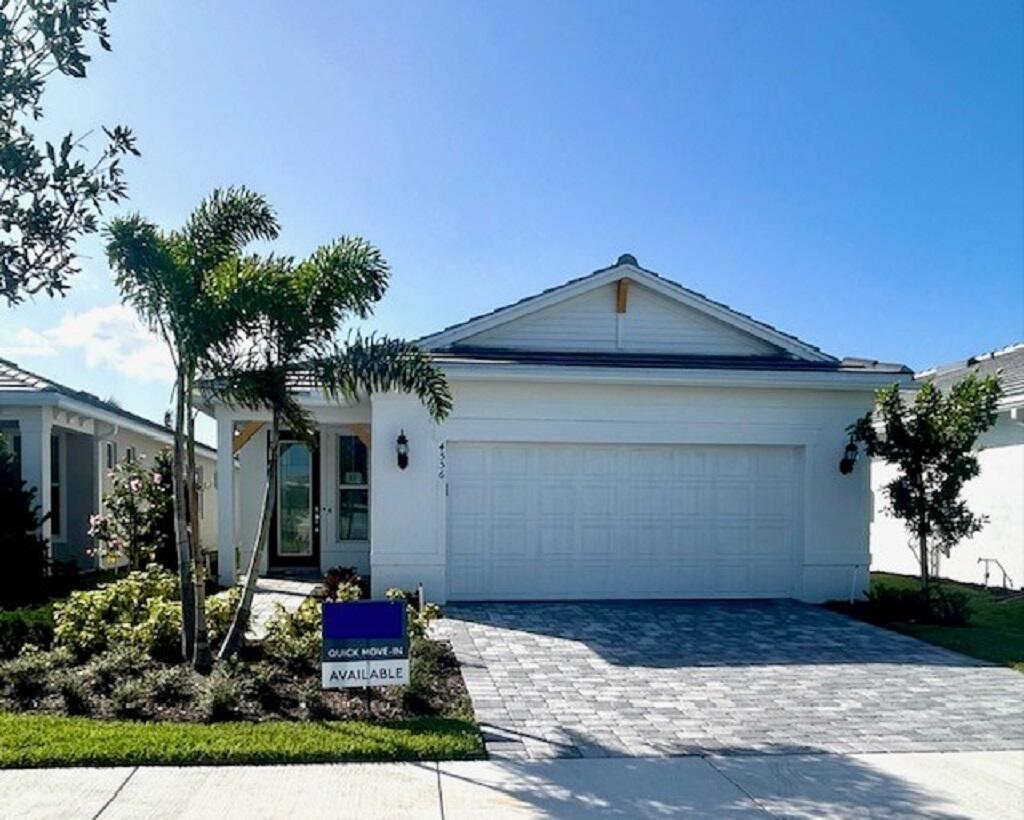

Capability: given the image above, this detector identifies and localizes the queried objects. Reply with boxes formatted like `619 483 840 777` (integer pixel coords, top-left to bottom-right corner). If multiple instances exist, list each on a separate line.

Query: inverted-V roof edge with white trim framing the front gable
417 254 838 362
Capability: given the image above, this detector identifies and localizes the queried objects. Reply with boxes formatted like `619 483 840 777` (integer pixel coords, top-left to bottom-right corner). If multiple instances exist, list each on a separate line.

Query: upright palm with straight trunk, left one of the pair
106 188 278 670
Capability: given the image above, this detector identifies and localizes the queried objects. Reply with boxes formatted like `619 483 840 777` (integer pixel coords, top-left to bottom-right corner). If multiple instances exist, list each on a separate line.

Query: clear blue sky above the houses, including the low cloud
0 0 1024 437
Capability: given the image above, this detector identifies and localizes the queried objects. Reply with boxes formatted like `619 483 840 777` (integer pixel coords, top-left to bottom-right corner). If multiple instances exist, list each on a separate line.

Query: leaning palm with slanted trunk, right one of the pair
210 236 452 659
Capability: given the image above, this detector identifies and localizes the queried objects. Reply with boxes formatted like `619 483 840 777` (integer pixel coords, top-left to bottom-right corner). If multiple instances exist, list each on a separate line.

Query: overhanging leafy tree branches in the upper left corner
0 0 138 305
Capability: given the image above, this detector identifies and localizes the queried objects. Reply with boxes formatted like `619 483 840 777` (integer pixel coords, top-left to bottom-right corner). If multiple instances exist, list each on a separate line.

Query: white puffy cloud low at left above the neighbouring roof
0 304 174 382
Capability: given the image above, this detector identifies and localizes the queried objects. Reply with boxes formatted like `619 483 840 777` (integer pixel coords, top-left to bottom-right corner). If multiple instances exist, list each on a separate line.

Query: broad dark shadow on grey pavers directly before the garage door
444 600 991 667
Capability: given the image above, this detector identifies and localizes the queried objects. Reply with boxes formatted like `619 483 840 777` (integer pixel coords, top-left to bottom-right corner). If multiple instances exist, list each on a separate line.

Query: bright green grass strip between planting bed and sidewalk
0 713 483 769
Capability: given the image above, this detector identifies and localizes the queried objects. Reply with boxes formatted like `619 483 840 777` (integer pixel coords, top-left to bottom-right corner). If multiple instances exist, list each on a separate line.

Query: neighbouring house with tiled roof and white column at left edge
0 358 217 569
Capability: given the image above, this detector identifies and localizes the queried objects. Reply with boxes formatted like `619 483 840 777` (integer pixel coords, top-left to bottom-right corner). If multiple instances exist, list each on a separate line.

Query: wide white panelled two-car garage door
447 442 801 600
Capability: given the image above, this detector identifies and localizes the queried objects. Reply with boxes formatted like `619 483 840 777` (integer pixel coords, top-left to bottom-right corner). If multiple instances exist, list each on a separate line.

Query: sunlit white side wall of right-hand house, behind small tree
871 413 1024 588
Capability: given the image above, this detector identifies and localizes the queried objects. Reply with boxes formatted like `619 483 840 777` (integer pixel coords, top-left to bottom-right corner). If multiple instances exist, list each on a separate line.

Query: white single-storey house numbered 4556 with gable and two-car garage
203 255 910 601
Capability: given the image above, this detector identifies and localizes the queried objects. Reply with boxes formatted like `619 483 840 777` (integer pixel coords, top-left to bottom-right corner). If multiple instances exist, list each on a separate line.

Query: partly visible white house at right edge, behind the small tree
871 343 1024 589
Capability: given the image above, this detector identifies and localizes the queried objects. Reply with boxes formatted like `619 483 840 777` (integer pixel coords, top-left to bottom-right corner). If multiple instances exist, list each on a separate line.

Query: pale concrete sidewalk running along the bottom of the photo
0 751 1024 820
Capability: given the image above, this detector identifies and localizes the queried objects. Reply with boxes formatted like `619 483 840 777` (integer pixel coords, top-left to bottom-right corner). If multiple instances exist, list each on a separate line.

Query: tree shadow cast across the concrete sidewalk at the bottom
440 740 964 818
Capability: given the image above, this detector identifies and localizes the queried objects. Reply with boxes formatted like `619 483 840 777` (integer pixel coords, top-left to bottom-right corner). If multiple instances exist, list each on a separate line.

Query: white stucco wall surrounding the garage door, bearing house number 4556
371 379 872 601
